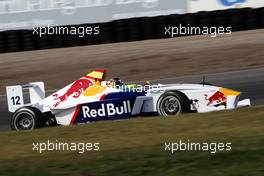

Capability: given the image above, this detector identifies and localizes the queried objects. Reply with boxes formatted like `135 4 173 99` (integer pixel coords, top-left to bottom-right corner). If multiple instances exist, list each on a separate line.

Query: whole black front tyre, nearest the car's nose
157 91 190 116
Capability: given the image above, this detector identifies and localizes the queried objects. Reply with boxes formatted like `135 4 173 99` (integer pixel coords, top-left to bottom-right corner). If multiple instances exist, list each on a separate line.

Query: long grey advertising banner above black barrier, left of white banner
0 0 187 31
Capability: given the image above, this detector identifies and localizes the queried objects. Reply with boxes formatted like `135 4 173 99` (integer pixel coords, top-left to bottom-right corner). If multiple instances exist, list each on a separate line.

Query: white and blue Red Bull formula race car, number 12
6 70 250 131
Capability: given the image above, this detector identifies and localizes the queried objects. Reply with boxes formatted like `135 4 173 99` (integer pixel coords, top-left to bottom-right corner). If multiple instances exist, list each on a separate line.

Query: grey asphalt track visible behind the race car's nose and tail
0 68 264 131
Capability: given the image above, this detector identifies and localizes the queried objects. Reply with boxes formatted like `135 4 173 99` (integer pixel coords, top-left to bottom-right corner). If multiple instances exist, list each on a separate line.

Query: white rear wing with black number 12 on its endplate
6 82 45 112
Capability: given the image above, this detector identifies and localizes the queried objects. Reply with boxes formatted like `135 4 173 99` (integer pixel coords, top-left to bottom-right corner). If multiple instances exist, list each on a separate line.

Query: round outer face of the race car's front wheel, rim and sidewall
160 96 181 116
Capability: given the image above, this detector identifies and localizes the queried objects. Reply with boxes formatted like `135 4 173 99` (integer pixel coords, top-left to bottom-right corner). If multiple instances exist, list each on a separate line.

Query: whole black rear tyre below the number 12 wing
10 107 44 131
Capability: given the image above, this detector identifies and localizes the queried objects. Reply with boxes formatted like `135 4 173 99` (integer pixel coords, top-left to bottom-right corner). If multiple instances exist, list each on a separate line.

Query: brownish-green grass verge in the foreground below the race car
0 107 264 176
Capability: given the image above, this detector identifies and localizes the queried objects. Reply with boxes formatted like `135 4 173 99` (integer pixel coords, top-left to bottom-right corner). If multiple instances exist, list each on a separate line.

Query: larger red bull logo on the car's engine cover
53 78 93 107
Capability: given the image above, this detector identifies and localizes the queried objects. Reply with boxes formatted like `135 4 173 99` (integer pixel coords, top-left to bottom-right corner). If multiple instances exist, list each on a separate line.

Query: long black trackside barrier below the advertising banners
0 8 264 53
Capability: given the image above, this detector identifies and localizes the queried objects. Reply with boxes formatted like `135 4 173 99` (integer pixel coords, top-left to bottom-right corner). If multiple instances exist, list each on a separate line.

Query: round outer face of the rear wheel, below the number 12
14 112 34 131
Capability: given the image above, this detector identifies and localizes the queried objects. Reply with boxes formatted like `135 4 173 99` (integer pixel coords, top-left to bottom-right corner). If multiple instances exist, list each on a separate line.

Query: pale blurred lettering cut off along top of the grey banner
0 0 160 15
